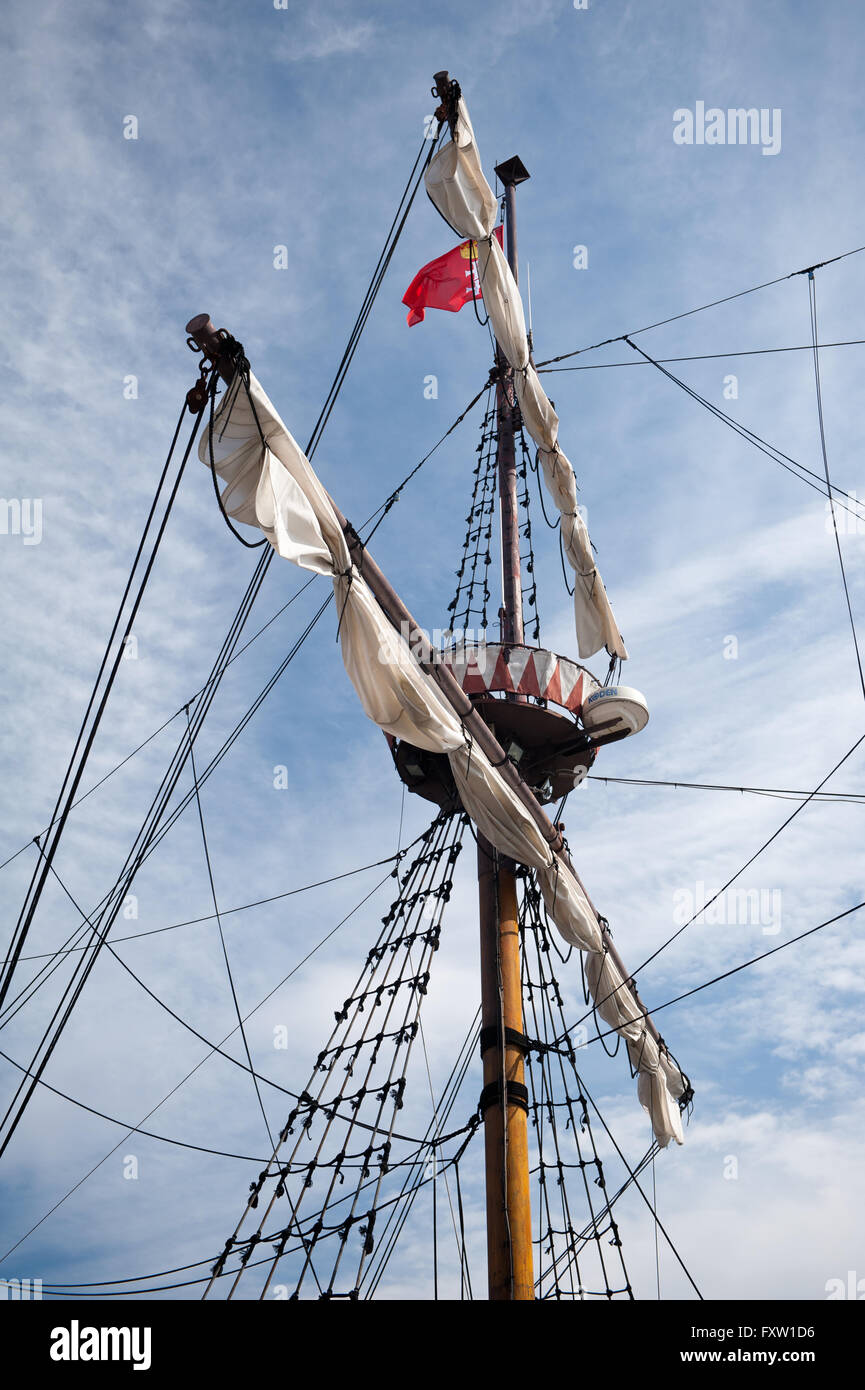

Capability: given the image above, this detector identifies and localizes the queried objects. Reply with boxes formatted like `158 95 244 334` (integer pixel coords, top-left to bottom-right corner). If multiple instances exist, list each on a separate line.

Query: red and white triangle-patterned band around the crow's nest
444 642 601 714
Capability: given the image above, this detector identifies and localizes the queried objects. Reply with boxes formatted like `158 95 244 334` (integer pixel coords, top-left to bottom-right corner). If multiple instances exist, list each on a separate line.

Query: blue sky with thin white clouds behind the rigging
0 0 865 1298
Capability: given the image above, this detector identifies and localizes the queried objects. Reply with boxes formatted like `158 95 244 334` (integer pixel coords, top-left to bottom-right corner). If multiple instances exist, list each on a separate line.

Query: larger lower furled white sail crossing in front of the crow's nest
199 375 684 1145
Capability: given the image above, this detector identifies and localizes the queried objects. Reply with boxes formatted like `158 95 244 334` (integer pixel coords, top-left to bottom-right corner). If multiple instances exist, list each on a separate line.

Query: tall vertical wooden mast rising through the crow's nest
477 146 534 1301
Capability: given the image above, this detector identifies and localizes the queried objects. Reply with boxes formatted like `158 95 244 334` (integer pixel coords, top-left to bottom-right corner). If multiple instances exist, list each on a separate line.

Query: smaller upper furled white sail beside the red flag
426 97 627 659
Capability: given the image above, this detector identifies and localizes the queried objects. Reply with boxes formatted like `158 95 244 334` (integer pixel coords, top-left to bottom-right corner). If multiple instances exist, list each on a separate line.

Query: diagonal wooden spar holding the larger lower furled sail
186 314 663 1047
